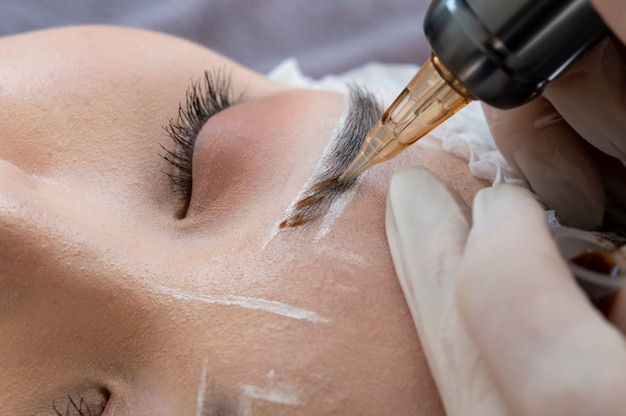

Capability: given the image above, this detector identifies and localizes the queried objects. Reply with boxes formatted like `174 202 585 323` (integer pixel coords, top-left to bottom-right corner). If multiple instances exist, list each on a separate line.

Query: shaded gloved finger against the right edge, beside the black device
543 37 626 160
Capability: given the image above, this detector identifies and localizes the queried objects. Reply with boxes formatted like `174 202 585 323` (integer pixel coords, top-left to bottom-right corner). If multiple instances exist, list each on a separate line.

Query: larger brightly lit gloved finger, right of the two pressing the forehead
459 185 626 416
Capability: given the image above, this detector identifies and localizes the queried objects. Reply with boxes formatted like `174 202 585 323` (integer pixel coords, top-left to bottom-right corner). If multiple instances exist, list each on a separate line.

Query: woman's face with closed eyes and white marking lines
0 28 481 415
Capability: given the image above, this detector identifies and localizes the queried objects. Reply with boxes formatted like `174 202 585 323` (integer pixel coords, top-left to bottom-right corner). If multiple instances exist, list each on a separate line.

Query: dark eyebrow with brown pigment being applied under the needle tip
280 84 383 228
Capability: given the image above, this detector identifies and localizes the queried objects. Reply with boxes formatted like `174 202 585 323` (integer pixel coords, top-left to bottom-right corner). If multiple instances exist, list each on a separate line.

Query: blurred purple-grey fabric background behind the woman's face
0 0 429 77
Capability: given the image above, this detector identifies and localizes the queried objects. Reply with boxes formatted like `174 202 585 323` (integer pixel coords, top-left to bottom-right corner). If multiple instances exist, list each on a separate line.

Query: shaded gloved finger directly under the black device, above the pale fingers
483 97 605 229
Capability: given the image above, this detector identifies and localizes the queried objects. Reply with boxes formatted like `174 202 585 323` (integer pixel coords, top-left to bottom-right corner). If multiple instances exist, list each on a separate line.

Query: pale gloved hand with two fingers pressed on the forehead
387 168 626 416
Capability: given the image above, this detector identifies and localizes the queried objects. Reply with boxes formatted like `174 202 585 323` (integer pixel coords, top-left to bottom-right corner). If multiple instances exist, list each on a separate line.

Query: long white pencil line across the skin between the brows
153 285 331 323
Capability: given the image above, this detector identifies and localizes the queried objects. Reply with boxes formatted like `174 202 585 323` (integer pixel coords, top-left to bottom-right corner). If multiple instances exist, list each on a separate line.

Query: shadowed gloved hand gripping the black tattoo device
484 0 626 230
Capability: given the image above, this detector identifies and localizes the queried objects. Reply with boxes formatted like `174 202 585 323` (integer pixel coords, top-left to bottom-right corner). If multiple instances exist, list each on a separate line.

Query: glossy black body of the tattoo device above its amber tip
424 0 607 109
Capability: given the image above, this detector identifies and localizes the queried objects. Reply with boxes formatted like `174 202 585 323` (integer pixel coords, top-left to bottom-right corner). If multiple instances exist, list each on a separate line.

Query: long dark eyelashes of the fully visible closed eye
161 70 241 218
